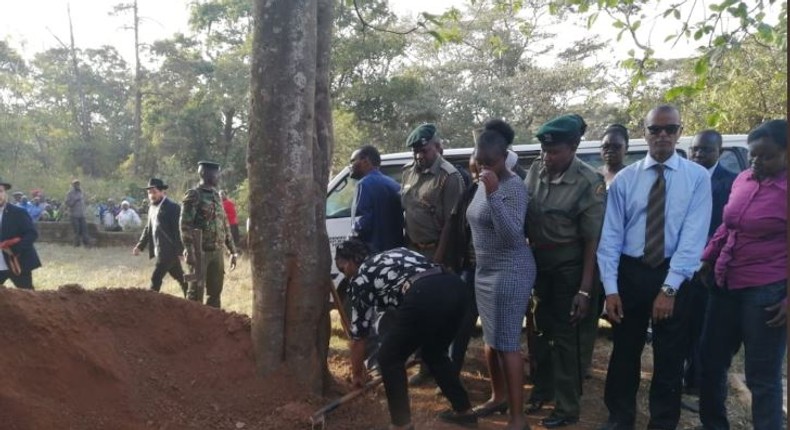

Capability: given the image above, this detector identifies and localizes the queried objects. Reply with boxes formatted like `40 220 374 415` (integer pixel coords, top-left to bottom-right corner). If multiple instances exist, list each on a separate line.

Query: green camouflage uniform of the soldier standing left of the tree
179 186 236 308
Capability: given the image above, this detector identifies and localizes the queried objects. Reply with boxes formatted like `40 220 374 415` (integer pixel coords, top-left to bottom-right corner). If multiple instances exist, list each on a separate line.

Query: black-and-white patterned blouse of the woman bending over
348 248 435 339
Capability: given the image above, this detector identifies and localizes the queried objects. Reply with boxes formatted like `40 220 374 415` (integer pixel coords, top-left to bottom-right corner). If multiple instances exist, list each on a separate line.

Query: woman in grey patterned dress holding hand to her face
467 119 535 430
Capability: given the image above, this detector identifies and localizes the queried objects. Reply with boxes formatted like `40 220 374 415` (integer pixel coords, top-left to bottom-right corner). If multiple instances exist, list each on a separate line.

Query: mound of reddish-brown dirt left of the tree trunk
0 285 358 430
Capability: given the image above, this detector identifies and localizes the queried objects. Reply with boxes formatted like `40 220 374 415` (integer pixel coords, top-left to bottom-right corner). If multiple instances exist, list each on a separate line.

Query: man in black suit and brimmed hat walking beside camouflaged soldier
132 178 187 297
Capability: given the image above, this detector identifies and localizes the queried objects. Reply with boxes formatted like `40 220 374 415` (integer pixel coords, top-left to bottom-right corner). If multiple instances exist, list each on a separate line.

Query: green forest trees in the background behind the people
0 0 787 220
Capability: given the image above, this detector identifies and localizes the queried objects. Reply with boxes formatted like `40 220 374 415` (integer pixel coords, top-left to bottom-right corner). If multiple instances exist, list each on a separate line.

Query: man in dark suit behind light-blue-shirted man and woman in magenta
683 130 738 402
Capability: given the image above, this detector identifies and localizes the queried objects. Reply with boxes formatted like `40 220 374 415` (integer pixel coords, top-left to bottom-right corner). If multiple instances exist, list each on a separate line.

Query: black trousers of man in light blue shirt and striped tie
604 256 690 430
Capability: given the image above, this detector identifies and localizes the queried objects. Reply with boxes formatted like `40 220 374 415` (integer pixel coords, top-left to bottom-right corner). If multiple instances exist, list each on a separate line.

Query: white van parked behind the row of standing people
326 134 749 282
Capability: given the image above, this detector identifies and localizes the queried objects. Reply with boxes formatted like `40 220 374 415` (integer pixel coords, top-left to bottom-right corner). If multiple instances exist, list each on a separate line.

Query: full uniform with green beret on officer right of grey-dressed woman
526 115 606 428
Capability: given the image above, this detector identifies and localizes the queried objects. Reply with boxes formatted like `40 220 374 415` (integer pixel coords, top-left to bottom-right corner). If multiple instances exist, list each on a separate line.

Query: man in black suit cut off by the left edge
0 179 41 290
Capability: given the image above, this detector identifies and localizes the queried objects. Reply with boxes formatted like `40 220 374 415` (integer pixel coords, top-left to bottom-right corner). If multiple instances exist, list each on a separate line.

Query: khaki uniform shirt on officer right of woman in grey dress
525 157 606 249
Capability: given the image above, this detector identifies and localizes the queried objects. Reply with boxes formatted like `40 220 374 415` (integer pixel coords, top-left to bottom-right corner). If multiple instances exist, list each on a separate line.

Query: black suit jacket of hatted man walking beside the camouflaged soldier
137 197 184 260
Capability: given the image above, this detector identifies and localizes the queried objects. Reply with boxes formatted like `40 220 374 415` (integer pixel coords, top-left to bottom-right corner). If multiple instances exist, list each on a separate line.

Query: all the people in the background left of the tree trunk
0 161 239 308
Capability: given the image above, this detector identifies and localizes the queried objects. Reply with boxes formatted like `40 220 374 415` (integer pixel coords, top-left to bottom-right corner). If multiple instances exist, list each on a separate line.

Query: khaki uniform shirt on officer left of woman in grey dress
401 156 464 245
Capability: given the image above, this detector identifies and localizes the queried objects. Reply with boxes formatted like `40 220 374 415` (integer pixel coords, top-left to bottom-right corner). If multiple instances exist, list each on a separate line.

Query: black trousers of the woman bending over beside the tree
379 274 471 426
